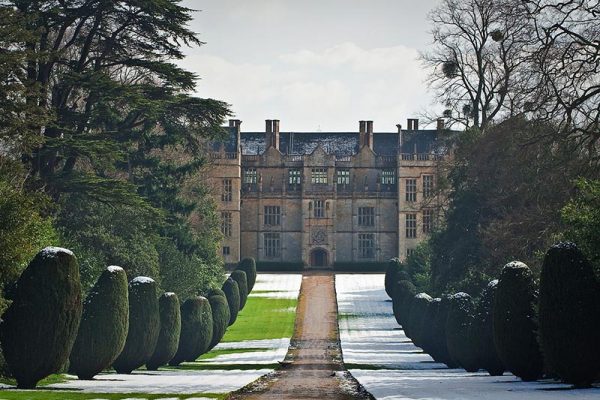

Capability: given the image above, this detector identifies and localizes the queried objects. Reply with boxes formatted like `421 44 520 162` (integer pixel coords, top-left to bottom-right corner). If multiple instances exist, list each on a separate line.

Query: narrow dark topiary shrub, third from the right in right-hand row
469 280 504 376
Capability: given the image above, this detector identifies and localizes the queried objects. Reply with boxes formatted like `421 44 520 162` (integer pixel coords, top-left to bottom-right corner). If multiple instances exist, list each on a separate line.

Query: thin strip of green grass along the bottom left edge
0 390 227 400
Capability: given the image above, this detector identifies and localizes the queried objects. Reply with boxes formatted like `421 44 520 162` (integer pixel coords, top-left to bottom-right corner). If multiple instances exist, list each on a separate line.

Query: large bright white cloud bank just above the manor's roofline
176 43 432 131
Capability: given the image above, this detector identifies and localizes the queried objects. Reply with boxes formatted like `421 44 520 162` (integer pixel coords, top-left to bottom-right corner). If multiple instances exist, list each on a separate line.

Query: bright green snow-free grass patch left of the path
222 297 298 342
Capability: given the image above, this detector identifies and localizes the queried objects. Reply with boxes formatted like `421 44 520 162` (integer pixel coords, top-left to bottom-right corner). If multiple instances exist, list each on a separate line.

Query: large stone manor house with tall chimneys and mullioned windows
208 119 446 266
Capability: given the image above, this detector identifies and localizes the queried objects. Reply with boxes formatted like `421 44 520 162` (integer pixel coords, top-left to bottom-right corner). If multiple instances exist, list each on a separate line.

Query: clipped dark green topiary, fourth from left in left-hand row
146 292 181 371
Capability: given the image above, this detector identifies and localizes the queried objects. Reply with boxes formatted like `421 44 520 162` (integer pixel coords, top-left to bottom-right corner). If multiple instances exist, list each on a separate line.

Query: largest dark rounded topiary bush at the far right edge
539 243 600 387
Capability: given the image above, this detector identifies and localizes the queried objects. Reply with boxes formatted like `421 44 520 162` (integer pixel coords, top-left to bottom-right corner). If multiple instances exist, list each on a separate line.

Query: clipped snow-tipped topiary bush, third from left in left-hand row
113 276 160 374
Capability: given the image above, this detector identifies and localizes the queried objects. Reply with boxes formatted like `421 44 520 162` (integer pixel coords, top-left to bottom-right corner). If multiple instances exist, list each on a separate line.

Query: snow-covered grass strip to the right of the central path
336 274 600 400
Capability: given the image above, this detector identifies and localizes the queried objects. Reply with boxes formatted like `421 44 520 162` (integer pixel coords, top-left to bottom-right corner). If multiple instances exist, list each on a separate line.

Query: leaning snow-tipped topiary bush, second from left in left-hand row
69 266 129 379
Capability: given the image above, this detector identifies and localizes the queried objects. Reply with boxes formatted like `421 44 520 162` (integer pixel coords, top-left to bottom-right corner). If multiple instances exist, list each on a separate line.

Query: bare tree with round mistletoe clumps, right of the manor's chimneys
422 0 531 128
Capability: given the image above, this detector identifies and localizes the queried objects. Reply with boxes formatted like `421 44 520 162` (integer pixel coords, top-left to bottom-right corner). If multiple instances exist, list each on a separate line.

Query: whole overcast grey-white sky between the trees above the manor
181 0 439 132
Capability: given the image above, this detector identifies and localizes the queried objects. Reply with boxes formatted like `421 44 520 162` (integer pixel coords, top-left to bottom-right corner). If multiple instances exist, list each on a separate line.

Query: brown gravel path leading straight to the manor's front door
229 271 373 400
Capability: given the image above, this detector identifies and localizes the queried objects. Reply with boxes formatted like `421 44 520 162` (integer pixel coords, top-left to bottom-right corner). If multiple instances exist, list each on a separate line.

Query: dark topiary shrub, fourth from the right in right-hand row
446 292 480 372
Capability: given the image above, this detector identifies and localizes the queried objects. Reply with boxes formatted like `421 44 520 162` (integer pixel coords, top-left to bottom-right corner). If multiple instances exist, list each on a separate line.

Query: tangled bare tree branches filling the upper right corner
522 0 600 157
